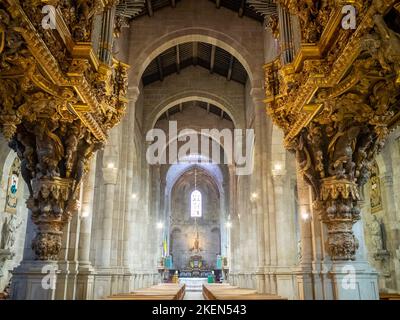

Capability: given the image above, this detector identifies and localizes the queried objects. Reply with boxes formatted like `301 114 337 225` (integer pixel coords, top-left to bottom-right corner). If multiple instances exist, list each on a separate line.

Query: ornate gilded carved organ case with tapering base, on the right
264 0 400 260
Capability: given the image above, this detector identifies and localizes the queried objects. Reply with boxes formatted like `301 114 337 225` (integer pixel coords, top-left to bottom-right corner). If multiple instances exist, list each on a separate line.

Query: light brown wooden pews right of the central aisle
203 283 287 300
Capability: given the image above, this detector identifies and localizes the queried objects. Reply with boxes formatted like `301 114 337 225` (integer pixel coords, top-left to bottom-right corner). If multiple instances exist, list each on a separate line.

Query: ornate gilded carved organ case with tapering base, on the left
0 0 128 260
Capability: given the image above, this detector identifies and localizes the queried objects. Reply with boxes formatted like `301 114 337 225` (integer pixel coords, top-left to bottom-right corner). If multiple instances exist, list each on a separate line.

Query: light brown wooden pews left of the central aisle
105 283 185 300
